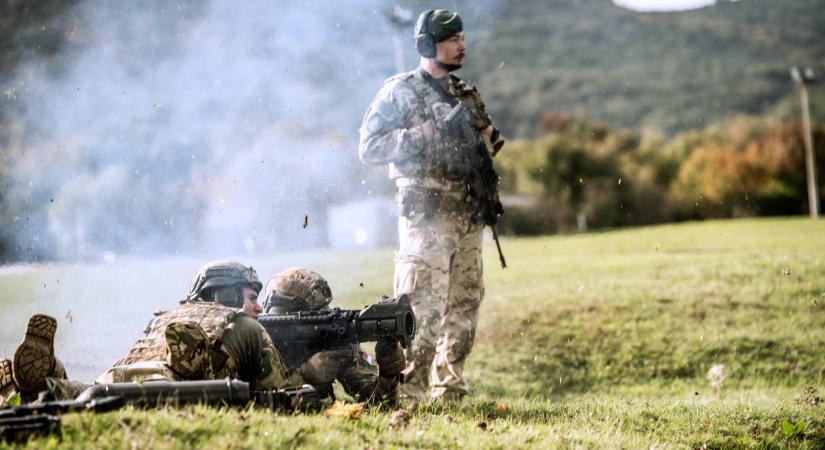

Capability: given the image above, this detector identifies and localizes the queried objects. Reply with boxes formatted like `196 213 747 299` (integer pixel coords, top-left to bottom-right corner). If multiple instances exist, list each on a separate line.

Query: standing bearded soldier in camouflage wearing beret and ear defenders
358 10 503 399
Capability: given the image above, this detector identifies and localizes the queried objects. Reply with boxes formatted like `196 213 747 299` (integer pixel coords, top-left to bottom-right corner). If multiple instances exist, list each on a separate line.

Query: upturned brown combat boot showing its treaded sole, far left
12 314 57 392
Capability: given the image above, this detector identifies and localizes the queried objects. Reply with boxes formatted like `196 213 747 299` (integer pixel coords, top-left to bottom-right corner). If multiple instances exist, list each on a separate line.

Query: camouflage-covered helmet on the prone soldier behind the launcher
263 267 332 313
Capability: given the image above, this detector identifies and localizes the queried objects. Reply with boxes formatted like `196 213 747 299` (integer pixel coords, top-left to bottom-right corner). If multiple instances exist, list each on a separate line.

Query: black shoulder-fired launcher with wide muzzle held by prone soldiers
258 294 415 369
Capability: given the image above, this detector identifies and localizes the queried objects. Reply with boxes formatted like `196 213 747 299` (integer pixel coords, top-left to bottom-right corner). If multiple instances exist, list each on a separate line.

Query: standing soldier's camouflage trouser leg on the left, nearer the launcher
394 213 456 399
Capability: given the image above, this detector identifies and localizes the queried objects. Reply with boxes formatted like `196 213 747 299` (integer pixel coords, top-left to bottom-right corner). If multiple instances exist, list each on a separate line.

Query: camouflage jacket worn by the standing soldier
358 68 492 192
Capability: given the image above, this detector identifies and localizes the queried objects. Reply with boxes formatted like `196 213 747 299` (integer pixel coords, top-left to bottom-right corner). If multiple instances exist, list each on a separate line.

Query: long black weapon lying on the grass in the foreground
0 378 321 442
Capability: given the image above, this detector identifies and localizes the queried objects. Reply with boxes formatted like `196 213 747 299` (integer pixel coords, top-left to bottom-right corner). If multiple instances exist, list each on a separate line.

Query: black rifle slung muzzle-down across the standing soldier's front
444 103 507 269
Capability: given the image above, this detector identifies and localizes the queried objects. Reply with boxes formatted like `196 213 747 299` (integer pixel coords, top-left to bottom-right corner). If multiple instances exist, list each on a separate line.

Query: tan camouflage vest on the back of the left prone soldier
115 302 239 366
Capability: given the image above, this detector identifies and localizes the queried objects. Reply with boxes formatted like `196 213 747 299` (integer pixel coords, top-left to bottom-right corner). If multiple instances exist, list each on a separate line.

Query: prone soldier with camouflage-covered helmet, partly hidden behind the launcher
263 268 404 405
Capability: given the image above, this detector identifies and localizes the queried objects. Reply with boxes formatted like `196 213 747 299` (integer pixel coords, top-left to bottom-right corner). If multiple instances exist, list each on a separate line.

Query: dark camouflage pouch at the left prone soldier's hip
164 322 212 380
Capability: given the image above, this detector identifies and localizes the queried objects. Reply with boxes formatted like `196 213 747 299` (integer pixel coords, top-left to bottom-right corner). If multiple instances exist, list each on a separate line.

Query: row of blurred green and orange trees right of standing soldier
499 113 825 234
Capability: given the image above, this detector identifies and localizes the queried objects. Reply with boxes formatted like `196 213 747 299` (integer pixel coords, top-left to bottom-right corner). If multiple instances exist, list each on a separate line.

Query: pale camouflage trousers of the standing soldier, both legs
394 209 484 399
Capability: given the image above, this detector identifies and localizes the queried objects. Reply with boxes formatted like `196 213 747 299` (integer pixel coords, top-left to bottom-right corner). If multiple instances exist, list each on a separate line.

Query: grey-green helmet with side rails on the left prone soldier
185 261 263 308
